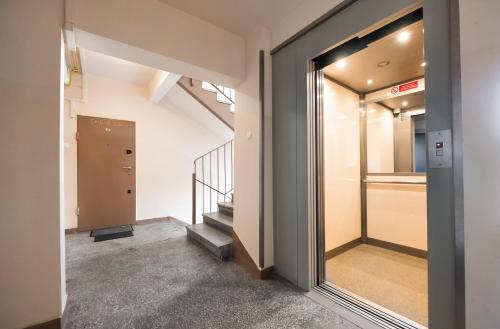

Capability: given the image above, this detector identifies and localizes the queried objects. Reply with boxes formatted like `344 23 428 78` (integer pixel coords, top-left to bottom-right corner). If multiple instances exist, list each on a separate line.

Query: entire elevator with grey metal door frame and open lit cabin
271 0 465 329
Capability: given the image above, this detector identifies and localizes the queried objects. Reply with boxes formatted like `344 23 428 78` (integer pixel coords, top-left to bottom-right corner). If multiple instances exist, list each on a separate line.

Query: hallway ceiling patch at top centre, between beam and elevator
158 0 304 36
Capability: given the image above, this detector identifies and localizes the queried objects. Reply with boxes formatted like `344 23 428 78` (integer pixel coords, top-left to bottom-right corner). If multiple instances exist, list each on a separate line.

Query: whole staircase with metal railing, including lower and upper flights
182 77 235 260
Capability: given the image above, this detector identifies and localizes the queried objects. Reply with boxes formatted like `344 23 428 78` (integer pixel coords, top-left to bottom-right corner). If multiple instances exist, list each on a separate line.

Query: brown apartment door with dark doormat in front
78 116 135 231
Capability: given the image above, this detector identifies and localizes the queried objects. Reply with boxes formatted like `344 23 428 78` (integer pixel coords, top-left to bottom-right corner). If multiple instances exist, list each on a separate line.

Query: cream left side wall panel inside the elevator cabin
323 79 361 251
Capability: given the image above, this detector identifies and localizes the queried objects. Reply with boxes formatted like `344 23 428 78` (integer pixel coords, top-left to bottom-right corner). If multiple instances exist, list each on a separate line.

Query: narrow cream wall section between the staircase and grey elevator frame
234 28 274 268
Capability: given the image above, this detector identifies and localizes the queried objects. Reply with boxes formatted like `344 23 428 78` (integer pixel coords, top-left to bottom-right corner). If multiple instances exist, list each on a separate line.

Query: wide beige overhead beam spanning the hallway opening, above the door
66 0 245 86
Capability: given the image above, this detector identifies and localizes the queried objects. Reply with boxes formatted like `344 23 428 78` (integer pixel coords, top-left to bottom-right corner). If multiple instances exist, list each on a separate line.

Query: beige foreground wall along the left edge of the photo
0 0 65 329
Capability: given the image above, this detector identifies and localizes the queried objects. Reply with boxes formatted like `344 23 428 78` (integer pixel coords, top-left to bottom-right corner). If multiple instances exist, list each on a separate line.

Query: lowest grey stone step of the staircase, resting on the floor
186 223 233 260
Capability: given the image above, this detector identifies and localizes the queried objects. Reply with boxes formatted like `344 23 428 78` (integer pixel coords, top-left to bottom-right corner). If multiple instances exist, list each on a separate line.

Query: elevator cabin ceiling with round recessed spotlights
324 21 425 92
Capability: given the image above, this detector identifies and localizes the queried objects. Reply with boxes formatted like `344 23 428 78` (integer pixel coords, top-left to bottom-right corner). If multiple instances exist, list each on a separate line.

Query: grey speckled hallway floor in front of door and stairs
66 221 358 329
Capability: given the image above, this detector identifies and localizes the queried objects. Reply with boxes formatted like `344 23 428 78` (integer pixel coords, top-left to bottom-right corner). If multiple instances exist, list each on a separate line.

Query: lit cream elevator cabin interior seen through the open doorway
318 14 428 327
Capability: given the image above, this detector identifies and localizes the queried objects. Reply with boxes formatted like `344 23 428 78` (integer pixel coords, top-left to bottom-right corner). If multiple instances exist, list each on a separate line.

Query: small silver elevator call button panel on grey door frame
427 129 453 168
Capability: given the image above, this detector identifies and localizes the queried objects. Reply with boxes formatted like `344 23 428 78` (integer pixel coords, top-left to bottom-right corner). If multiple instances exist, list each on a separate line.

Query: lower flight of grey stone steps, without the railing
186 202 233 260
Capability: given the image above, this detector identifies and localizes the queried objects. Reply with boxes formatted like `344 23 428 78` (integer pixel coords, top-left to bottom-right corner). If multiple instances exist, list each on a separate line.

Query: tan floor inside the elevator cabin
326 244 428 326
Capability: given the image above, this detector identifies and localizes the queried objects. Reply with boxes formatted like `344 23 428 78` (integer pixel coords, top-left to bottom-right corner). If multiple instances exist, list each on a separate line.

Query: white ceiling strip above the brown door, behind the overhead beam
80 48 156 86
